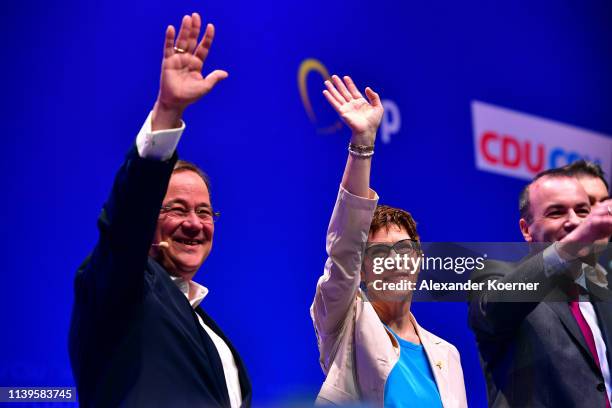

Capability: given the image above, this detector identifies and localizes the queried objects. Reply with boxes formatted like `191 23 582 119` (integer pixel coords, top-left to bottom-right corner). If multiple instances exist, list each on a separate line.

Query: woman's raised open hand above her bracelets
323 75 384 146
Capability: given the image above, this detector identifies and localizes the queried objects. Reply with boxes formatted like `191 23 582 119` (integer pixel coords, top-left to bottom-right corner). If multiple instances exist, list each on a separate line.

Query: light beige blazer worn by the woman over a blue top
310 188 467 408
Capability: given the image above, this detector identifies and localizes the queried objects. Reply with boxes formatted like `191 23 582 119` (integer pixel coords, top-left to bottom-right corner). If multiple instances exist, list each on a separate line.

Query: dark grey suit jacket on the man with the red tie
469 252 612 407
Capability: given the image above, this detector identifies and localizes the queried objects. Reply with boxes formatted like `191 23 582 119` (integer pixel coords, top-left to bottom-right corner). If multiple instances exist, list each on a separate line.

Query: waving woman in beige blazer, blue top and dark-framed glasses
310 75 467 408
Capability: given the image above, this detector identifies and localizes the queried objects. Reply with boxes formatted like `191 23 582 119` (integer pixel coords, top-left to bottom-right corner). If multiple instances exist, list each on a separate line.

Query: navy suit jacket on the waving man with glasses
69 148 251 407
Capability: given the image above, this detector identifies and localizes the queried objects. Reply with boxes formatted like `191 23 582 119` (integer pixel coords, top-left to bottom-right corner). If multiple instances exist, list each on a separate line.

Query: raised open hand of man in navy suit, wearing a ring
152 13 228 130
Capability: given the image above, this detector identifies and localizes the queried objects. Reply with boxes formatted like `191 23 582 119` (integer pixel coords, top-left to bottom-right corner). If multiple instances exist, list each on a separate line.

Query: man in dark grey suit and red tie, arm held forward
469 164 612 408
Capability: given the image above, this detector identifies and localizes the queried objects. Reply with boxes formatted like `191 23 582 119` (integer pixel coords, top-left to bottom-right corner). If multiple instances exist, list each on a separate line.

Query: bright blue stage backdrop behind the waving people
0 0 612 407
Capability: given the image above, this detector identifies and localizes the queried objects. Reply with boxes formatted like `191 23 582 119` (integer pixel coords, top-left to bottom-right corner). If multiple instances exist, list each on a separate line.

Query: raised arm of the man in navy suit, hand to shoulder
75 13 227 311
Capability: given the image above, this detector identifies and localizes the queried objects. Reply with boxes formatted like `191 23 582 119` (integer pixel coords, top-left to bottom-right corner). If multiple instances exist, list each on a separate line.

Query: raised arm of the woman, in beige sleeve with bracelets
311 75 383 360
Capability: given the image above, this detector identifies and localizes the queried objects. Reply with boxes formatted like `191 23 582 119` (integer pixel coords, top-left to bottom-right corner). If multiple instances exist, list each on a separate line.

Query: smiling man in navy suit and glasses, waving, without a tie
69 13 251 408
